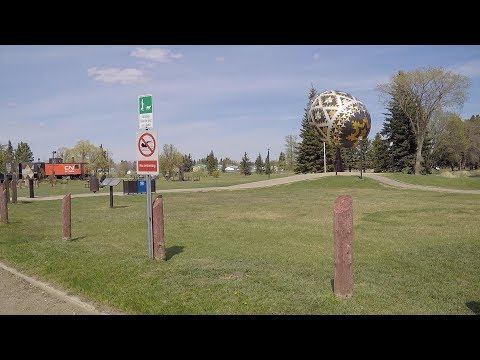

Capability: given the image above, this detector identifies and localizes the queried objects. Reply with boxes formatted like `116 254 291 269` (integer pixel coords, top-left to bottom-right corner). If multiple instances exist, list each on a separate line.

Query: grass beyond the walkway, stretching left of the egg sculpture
17 172 293 197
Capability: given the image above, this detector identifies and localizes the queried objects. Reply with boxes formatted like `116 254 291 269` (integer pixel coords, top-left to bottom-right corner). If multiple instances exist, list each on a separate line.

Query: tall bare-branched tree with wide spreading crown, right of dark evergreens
377 68 470 175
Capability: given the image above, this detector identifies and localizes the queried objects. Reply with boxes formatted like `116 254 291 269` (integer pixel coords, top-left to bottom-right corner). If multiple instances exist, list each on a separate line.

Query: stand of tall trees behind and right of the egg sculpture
285 68 480 174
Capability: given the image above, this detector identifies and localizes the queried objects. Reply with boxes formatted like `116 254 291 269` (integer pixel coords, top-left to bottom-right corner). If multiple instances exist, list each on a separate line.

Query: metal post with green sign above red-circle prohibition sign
136 94 159 259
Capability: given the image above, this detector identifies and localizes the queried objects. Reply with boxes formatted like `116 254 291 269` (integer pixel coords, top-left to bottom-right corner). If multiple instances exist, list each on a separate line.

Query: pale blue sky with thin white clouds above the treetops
0 45 480 162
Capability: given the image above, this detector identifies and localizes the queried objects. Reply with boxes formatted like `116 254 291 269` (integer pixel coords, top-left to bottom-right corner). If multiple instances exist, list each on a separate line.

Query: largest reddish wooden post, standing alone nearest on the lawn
333 195 353 298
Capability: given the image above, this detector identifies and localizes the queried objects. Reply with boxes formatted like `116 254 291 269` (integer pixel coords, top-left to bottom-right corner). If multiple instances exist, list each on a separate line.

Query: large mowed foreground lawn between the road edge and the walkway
0 176 480 314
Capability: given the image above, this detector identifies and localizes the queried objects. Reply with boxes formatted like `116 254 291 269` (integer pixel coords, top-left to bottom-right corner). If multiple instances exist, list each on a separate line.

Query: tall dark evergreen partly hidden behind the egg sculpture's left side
294 86 323 173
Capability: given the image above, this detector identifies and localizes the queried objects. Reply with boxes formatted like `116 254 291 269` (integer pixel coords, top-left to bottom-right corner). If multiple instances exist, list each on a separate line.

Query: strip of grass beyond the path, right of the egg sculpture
381 171 480 190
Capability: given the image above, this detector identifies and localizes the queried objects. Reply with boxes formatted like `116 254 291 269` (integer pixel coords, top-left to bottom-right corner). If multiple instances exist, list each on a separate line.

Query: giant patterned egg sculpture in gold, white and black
308 90 371 149
